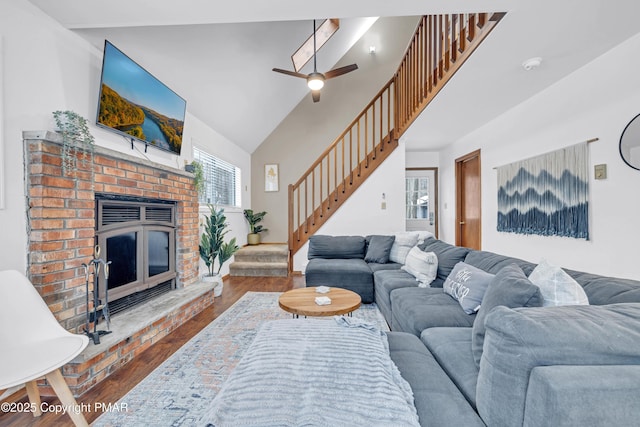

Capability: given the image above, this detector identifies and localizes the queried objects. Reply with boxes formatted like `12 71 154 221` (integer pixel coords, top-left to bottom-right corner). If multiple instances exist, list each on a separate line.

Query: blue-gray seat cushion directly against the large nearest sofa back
420 328 478 408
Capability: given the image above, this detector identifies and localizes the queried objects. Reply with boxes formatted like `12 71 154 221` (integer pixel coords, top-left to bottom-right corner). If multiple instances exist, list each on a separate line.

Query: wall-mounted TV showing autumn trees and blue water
96 40 187 154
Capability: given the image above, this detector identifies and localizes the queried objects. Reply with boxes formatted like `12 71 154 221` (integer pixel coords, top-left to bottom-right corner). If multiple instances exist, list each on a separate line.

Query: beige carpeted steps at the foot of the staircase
229 243 289 277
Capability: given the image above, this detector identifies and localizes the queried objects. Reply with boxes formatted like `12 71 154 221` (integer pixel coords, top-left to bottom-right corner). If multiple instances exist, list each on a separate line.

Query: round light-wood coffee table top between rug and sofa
278 287 361 317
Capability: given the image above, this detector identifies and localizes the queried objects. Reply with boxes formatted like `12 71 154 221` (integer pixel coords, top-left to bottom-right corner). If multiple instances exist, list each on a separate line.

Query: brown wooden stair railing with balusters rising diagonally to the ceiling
289 13 505 255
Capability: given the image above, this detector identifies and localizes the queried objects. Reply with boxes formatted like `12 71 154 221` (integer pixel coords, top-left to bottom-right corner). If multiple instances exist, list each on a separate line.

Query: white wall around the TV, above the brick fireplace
0 0 251 272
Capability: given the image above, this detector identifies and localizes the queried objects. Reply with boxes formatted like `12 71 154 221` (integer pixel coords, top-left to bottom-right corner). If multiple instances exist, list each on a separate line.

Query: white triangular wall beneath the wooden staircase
293 143 405 272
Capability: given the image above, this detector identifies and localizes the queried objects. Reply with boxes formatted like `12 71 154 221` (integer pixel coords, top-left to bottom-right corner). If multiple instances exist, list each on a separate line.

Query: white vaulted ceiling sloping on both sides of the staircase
30 0 640 152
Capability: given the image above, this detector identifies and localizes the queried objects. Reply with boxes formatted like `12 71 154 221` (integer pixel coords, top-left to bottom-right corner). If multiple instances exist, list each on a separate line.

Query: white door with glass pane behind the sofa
405 168 438 237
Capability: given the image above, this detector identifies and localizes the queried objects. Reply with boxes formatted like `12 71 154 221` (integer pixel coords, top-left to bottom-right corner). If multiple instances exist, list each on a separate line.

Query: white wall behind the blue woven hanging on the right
440 34 640 279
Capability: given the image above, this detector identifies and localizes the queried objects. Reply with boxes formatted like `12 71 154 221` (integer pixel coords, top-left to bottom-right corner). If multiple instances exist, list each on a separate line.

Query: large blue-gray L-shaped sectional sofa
307 236 640 427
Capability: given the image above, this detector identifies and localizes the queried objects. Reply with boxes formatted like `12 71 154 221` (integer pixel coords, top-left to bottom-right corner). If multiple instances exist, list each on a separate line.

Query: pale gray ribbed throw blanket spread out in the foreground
200 317 419 427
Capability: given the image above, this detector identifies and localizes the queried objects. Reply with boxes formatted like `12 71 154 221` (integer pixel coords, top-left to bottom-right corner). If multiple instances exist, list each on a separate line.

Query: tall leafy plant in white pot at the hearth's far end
200 205 240 296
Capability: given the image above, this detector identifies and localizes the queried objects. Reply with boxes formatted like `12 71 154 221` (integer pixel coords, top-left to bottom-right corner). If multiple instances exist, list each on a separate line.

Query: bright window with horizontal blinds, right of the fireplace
193 147 242 207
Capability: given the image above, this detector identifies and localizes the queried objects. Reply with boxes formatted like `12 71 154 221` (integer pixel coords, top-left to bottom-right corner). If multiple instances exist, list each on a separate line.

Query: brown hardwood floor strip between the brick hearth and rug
0 276 304 427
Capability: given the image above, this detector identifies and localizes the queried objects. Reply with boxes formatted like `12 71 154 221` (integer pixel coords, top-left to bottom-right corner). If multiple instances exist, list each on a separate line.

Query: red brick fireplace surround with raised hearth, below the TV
23 131 213 395
